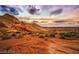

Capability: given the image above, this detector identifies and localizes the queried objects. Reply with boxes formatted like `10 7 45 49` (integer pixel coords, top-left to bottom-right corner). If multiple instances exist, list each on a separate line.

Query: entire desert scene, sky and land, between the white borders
0 5 79 54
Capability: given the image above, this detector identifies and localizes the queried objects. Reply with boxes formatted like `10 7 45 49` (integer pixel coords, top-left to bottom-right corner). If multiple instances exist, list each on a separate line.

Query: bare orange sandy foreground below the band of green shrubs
0 35 79 54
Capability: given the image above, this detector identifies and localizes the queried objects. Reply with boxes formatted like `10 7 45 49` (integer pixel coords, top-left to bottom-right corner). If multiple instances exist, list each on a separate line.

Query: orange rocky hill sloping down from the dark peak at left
0 14 46 31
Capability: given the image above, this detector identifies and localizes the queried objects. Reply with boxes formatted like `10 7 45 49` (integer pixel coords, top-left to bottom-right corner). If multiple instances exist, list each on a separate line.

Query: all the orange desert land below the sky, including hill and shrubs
0 14 79 54
